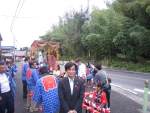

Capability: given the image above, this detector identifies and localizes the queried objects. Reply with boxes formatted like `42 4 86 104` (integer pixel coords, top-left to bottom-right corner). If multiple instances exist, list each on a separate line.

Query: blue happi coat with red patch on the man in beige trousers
26 68 39 91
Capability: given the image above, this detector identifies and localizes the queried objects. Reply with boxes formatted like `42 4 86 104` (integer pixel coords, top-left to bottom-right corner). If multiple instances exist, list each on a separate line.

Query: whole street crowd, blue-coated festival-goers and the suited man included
0 57 111 113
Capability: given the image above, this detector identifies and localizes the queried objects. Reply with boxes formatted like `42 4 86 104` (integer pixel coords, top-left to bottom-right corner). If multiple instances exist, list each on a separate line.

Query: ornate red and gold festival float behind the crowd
30 40 60 70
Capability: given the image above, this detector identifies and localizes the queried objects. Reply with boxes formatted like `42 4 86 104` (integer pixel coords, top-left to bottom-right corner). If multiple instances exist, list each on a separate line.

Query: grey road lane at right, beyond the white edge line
106 70 150 101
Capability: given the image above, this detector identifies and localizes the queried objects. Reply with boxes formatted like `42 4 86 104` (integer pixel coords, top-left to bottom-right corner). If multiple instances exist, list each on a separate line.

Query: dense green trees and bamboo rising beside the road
40 0 150 71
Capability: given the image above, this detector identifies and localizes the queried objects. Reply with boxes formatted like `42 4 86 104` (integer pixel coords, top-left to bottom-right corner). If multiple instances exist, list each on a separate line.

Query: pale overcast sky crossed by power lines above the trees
0 0 106 49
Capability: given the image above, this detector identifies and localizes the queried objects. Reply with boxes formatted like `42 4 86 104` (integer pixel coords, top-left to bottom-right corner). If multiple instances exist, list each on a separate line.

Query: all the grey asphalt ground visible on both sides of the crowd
12 63 150 113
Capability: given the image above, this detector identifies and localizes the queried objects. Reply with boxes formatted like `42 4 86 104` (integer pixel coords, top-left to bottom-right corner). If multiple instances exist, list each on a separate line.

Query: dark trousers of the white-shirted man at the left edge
0 92 14 113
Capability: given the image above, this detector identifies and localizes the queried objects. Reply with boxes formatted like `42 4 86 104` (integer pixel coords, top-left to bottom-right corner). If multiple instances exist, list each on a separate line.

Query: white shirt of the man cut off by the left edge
0 73 10 93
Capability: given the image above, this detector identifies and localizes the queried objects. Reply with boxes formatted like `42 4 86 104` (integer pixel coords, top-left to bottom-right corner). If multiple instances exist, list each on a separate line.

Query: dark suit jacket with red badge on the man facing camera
58 77 84 113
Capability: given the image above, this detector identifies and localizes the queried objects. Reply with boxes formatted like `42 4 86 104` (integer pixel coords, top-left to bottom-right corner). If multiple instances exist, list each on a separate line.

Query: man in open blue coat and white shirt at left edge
0 62 15 113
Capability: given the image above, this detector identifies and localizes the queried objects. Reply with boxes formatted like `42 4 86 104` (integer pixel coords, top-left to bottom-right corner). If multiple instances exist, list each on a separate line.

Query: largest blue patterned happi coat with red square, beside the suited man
32 75 60 113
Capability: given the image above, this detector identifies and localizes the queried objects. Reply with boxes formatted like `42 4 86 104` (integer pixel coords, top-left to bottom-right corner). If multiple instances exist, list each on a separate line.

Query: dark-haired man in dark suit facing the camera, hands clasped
58 62 84 113
